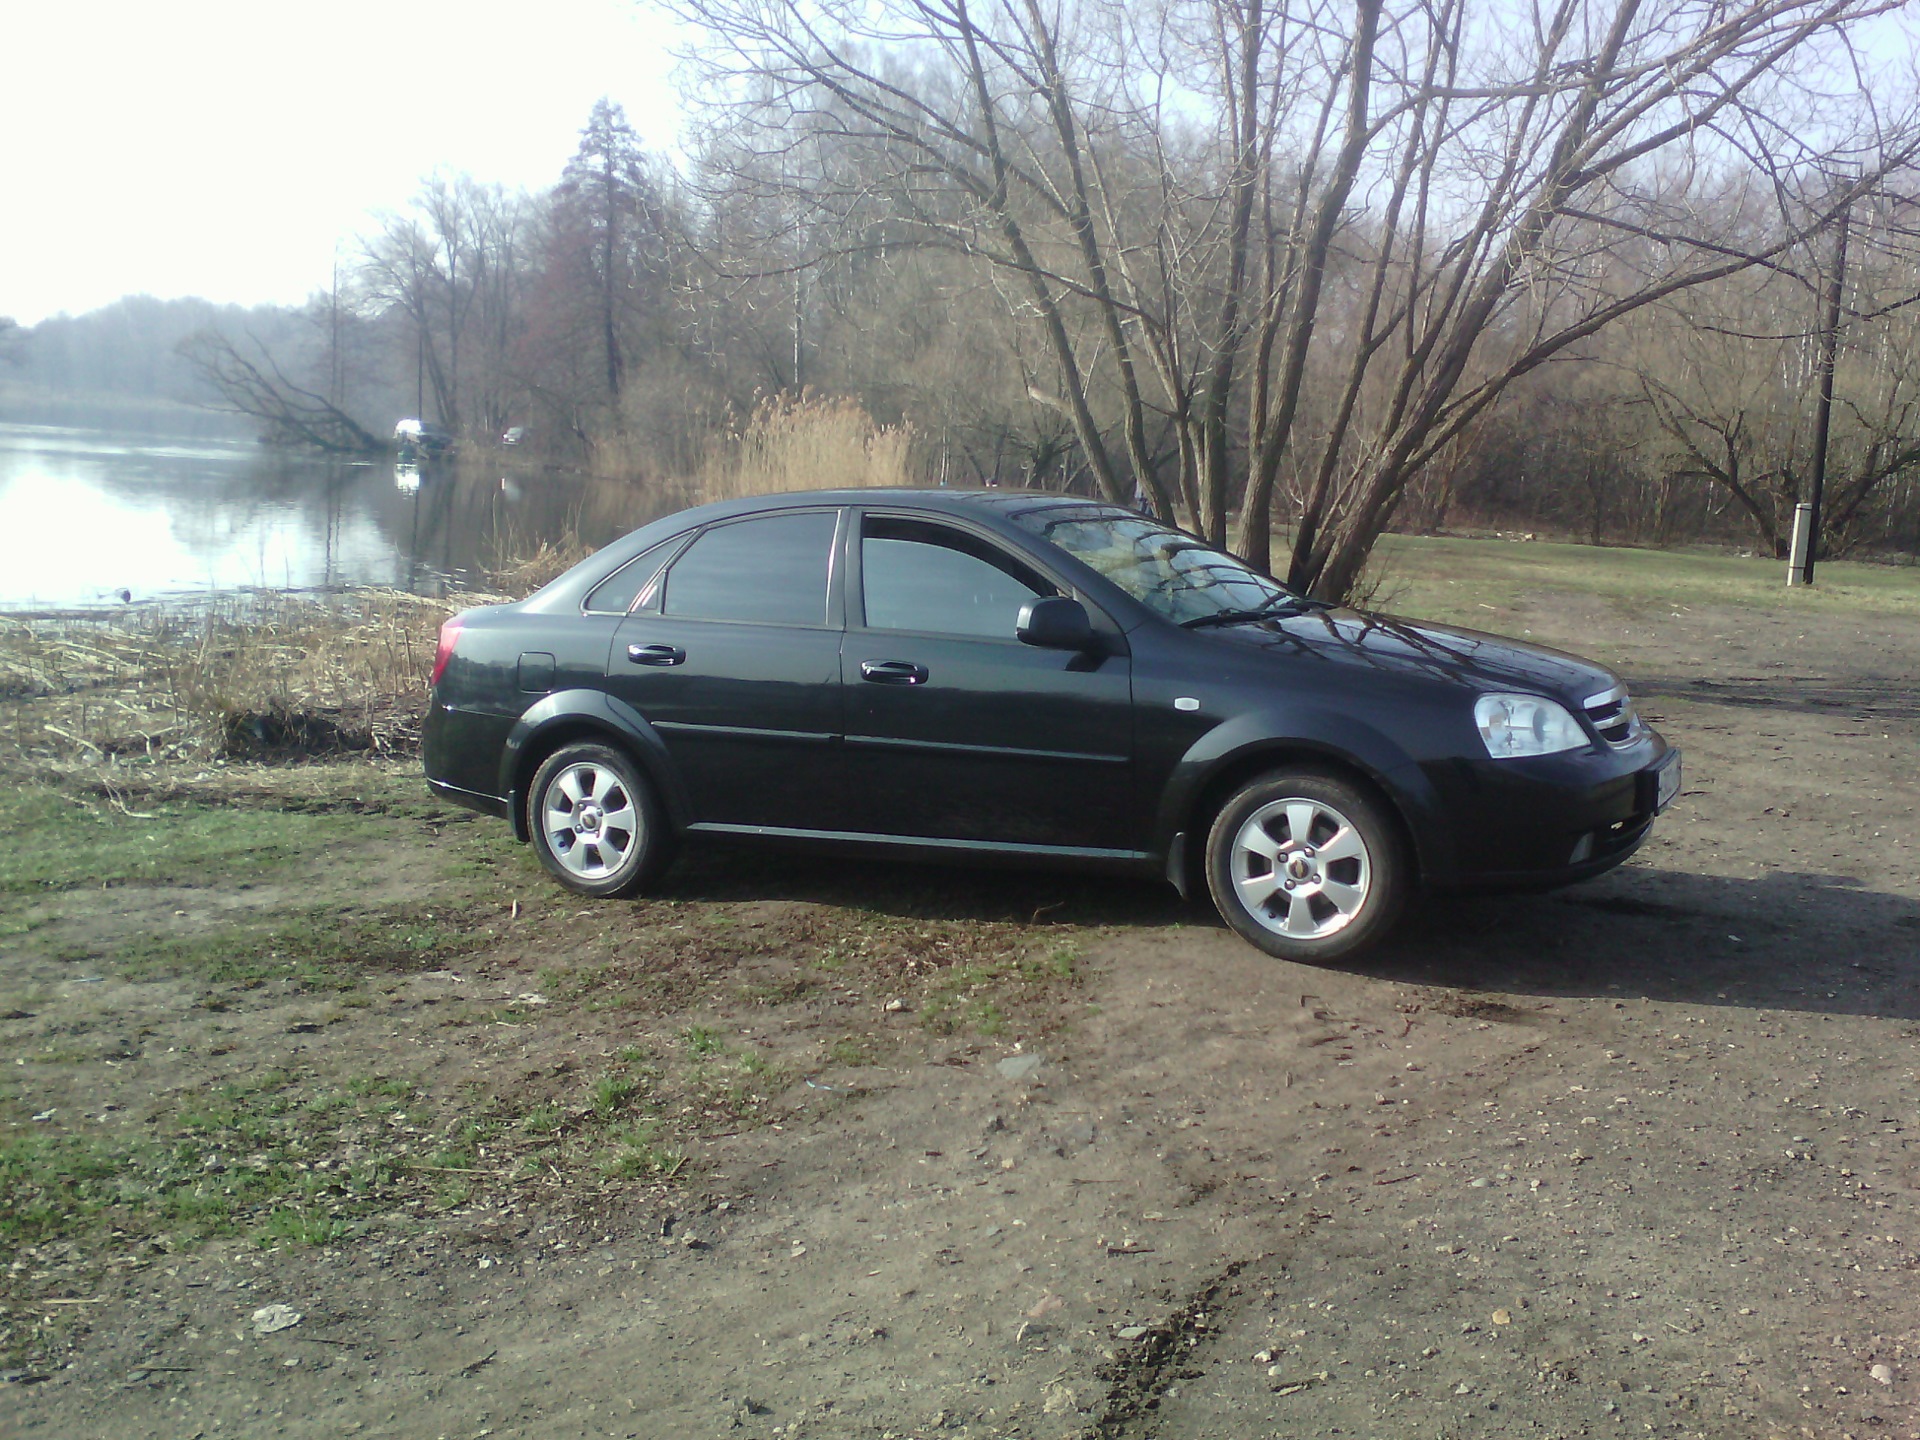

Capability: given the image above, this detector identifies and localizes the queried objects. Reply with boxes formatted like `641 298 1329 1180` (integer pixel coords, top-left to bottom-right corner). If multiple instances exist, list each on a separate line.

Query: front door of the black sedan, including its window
841 511 1140 851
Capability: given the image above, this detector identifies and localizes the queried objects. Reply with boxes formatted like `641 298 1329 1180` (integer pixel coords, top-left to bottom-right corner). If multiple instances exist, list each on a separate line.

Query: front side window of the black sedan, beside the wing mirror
860 515 1054 639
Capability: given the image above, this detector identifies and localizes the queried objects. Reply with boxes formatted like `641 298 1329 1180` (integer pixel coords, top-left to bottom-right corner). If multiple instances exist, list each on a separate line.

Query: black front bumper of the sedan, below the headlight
1427 730 1680 889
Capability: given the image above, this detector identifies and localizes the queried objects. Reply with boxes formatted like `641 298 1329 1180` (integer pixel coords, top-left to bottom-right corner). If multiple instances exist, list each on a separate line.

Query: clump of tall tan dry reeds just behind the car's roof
697 396 920 499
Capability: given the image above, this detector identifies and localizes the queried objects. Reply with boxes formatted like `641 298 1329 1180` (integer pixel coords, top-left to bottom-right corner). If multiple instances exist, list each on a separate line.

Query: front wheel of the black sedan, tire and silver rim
1206 770 1409 964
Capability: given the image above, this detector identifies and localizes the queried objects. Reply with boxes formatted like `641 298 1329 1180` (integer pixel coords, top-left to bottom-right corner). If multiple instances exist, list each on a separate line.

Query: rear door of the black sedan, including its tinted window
607 507 843 829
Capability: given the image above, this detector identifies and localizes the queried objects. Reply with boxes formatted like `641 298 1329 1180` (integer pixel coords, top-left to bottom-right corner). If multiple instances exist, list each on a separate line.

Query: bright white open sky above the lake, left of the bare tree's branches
0 0 678 324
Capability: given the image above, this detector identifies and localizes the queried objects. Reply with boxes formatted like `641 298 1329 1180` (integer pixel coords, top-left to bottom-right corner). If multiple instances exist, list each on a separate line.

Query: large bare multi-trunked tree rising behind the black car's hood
684 0 1914 595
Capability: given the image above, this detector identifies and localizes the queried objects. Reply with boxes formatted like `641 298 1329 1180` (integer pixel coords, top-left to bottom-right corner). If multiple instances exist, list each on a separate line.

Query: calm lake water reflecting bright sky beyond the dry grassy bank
0 422 666 611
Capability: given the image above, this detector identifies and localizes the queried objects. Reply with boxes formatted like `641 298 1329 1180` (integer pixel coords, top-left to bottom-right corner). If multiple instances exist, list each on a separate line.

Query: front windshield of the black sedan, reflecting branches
1008 505 1292 624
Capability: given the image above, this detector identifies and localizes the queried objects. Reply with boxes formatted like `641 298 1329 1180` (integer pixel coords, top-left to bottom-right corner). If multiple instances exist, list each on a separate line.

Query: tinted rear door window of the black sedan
660 511 837 626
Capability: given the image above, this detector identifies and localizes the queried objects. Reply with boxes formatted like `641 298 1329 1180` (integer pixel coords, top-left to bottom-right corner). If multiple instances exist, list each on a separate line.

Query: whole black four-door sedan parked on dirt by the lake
424 490 1680 960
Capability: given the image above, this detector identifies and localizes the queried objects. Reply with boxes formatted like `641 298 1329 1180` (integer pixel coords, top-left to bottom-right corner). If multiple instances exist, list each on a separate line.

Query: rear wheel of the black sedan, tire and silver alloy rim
526 743 674 899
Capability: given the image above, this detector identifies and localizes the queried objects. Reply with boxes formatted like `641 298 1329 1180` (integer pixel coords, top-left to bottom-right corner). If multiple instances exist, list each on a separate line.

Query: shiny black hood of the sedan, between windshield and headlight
1212 609 1619 705
